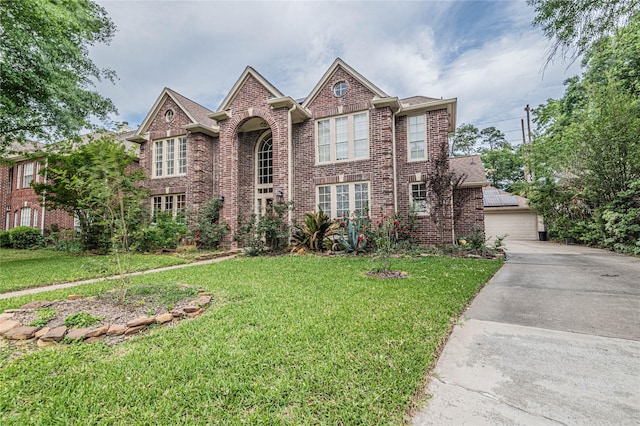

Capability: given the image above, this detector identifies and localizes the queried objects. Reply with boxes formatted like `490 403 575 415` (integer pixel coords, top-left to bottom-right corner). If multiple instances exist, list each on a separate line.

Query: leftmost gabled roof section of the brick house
127 87 217 142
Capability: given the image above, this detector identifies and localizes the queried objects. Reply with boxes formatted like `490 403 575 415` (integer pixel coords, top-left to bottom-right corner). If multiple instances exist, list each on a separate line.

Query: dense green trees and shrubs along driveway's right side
527 10 640 253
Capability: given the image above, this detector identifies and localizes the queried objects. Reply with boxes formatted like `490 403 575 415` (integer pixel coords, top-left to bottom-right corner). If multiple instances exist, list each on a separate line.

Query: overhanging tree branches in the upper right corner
527 0 640 63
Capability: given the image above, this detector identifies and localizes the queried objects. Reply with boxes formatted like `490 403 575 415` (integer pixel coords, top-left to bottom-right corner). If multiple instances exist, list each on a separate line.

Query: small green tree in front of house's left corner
32 134 147 251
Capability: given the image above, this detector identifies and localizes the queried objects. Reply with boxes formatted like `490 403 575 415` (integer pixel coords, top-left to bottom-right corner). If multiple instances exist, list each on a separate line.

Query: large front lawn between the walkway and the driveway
0 257 501 425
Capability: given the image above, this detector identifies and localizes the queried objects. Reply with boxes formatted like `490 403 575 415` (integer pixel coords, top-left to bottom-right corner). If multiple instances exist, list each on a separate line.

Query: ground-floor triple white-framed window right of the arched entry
316 181 371 219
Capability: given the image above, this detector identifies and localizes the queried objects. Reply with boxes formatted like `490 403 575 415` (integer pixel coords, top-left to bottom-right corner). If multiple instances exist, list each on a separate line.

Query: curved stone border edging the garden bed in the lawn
0 292 211 347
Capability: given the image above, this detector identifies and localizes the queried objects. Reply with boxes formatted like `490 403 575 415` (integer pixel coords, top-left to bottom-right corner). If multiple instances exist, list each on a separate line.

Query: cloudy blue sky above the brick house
90 0 579 142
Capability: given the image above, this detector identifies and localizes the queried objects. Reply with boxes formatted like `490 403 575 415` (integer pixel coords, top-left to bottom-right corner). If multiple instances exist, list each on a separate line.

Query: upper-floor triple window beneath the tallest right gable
316 112 369 163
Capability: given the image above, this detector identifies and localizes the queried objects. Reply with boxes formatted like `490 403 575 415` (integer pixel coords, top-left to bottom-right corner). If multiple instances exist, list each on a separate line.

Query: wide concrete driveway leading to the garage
413 242 640 425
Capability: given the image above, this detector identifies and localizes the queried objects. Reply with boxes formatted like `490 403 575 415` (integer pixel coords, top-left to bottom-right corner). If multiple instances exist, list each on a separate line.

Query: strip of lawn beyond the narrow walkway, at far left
0 248 188 293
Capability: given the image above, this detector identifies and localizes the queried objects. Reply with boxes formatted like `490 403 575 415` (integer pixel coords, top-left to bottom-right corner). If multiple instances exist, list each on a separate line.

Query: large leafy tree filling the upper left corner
0 0 115 154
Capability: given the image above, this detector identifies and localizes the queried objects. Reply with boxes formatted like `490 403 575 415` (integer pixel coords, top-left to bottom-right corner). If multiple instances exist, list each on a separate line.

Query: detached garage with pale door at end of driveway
482 187 538 241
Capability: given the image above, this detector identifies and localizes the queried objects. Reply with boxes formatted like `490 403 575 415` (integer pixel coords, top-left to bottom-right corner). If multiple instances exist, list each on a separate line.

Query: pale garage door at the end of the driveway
484 210 538 241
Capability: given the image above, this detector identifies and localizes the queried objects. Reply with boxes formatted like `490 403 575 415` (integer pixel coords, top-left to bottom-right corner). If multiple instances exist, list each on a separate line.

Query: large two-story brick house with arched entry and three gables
128 59 486 244
